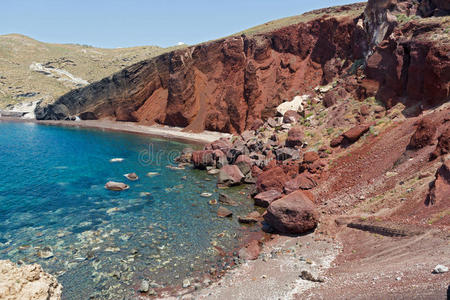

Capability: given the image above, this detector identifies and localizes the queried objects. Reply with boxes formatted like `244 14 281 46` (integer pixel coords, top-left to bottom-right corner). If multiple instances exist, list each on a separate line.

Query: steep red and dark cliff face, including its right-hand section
36 1 450 133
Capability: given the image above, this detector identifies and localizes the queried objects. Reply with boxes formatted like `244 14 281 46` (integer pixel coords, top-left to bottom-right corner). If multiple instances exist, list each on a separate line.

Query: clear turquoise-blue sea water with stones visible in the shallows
0 123 253 299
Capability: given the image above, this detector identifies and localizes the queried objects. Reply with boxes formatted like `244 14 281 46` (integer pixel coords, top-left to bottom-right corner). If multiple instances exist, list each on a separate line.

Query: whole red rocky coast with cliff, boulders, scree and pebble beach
1 0 450 299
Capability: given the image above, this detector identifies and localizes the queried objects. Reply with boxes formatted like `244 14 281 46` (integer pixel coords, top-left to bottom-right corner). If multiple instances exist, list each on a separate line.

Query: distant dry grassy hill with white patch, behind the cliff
0 34 185 109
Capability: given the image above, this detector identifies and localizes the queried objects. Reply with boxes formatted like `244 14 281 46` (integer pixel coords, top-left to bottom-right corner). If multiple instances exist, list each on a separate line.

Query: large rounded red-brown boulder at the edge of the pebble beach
264 191 319 234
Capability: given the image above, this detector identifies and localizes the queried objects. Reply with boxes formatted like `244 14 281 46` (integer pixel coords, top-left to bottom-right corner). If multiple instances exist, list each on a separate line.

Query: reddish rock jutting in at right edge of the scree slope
427 159 450 205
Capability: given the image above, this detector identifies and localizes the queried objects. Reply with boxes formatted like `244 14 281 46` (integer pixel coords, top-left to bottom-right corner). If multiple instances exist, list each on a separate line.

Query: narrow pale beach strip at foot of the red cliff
0 117 230 145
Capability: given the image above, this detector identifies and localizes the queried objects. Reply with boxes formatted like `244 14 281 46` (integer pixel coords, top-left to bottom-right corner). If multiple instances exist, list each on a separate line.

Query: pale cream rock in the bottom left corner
0 260 62 300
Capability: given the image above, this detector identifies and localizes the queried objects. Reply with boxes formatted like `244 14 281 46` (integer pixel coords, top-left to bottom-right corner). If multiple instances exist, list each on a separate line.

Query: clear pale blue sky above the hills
0 0 363 48
